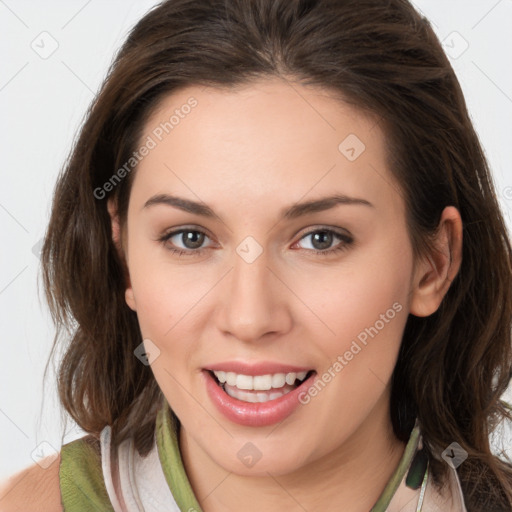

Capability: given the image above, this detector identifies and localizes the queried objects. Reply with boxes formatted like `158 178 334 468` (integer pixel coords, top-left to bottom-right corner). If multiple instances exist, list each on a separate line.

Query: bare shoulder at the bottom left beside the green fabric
0 455 63 512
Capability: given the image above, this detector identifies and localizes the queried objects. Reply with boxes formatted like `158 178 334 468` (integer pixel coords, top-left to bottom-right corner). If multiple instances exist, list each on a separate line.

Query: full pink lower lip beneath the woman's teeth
202 370 316 427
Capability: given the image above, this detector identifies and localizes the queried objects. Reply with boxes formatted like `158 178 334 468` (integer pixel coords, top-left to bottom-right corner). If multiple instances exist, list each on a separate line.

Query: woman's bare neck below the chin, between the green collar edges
179 394 405 512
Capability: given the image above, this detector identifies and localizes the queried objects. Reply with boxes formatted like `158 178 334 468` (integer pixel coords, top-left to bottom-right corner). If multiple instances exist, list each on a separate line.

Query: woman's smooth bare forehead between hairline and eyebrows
133 79 398 217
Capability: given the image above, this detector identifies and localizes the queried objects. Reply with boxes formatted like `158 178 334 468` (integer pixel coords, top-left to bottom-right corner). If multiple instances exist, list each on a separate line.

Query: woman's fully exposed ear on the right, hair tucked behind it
410 206 462 317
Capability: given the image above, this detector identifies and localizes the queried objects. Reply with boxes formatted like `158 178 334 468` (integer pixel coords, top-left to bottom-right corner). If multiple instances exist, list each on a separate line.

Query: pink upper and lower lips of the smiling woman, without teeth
201 362 316 427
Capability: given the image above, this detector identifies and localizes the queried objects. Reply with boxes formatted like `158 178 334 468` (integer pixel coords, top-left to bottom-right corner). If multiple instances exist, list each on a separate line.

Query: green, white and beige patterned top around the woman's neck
59 400 467 512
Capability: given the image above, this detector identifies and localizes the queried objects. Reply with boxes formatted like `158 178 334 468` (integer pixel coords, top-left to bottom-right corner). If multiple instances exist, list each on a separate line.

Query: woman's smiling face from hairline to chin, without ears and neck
123 79 424 475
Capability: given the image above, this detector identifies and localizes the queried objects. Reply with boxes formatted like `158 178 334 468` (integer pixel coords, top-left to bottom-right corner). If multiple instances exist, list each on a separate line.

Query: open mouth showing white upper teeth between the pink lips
207 370 316 403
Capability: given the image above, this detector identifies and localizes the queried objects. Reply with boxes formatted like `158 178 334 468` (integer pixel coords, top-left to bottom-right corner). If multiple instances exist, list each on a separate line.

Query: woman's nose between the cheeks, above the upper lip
218 246 292 342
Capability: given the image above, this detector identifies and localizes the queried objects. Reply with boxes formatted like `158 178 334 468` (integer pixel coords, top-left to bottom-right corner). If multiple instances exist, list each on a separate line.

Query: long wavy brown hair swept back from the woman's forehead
42 0 512 512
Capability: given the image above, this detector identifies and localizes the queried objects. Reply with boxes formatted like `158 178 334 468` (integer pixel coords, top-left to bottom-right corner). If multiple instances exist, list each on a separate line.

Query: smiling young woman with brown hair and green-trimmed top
4 0 512 512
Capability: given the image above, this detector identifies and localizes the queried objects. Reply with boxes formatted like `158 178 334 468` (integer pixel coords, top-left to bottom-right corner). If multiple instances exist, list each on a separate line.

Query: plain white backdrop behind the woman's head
0 0 512 478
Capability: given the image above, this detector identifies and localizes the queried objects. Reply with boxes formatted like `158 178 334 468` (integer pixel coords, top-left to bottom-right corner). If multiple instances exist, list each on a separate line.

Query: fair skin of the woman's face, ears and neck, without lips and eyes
0 79 462 512
